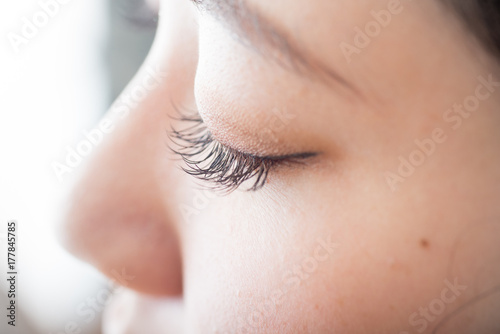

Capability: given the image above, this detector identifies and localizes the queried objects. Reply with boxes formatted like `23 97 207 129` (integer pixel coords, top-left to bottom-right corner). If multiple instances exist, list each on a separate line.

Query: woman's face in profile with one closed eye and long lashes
63 0 500 333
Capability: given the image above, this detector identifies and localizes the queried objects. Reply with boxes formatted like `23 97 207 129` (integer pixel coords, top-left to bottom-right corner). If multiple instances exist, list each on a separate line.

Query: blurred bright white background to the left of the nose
0 0 154 334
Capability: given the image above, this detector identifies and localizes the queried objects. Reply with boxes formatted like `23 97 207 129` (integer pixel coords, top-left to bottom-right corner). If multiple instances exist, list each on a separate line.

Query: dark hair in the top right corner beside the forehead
443 0 500 59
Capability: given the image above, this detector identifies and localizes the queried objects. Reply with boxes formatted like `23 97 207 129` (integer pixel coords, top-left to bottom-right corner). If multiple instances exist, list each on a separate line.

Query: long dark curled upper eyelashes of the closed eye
170 112 315 192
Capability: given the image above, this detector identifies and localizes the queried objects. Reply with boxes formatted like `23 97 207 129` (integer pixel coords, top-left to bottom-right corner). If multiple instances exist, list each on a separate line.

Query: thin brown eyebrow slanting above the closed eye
191 0 359 94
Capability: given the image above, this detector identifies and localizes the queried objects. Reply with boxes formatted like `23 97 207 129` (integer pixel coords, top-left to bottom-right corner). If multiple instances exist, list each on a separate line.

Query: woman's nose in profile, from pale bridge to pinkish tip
61 0 197 295
